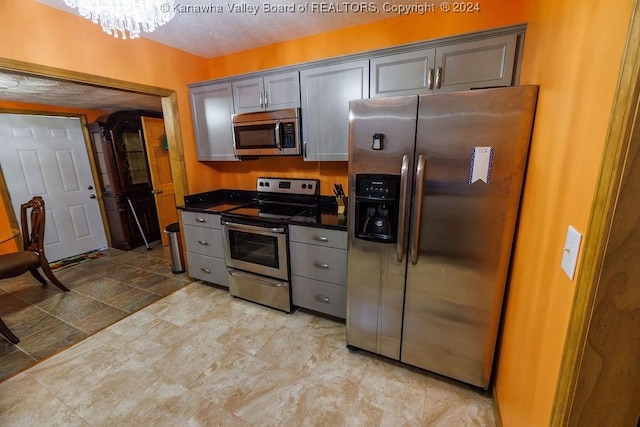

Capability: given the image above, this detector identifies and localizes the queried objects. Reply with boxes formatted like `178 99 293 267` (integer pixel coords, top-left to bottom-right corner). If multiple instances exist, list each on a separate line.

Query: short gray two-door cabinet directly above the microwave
232 71 300 113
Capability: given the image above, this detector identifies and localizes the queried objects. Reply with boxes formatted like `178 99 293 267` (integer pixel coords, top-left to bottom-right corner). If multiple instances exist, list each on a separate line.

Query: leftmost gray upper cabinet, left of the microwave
190 83 238 161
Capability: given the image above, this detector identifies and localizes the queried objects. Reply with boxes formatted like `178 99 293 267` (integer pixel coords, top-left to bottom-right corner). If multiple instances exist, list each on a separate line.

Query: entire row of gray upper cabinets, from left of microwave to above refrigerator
190 26 525 161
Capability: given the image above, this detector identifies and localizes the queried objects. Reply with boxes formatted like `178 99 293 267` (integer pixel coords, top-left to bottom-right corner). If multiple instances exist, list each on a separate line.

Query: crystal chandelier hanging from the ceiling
64 0 175 39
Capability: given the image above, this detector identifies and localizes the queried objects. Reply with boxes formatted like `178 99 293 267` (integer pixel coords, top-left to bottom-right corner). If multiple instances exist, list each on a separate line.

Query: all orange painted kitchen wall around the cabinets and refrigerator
5 0 633 426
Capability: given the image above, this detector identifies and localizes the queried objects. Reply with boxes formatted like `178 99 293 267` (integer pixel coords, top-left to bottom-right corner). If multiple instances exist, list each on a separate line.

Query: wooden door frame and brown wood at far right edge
549 0 640 426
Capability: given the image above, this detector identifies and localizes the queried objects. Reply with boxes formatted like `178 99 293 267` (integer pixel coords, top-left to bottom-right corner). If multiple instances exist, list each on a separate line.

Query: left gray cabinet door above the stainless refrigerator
369 49 436 98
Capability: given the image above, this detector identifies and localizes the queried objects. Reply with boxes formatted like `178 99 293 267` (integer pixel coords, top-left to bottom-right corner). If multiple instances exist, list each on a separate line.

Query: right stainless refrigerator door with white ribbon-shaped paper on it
401 86 537 388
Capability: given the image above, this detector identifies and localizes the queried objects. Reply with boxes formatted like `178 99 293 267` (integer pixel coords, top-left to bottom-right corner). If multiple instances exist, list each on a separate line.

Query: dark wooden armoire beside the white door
87 111 162 251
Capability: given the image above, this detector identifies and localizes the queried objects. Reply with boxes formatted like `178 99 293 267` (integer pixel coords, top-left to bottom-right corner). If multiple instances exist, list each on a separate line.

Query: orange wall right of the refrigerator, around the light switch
496 0 633 426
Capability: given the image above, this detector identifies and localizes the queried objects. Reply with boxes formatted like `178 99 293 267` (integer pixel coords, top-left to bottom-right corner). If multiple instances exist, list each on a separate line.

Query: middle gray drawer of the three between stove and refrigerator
290 242 347 286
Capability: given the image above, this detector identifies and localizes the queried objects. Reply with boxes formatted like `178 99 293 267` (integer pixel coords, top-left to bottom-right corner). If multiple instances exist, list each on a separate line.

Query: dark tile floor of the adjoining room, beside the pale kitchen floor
0 242 190 382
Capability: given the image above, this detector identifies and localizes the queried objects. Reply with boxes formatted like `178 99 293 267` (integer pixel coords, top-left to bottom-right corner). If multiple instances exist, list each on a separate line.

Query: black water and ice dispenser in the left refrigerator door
355 174 400 243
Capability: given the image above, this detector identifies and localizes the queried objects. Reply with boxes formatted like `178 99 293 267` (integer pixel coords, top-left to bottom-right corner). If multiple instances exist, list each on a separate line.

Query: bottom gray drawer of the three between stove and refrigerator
291 276 347 319
